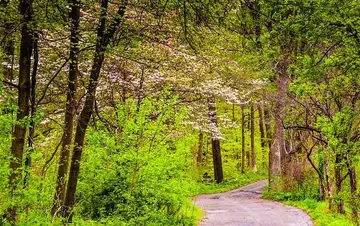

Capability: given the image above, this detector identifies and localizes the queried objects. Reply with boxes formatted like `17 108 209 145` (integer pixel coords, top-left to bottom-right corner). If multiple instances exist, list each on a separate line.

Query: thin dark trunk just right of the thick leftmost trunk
24 32 39 187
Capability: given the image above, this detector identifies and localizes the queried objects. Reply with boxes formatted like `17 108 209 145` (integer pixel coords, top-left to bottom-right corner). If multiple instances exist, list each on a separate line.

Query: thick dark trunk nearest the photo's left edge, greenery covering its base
8 0 33 223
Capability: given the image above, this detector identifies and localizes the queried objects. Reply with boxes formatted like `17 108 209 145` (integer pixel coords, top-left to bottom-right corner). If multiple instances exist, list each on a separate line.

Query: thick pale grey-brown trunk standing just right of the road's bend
269 59 289 186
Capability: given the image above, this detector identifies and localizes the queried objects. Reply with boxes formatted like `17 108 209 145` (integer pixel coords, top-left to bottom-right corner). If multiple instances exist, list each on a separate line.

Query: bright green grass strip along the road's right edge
263 190 354 226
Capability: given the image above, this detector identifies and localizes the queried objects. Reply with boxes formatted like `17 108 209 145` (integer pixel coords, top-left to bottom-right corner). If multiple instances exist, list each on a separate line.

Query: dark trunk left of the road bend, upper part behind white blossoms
208 97 224 183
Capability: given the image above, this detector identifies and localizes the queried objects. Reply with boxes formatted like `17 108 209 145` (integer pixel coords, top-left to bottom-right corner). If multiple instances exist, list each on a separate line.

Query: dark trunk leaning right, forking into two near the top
64 0 127 222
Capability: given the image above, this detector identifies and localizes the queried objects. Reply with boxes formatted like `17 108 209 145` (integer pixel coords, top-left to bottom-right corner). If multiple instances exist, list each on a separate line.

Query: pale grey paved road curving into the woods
195 180 313 226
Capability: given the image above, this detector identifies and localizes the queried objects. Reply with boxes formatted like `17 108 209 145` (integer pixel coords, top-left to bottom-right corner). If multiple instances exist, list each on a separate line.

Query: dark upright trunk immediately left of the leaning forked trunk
51 0 81 215
